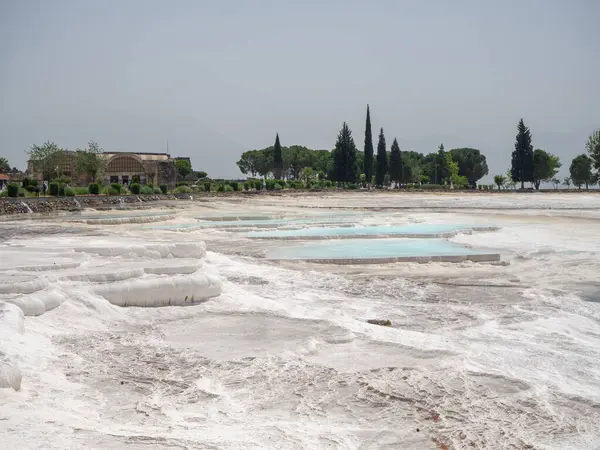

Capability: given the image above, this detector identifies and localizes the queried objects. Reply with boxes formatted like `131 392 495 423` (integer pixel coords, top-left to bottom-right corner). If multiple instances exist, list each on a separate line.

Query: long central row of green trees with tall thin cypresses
237 106 489 188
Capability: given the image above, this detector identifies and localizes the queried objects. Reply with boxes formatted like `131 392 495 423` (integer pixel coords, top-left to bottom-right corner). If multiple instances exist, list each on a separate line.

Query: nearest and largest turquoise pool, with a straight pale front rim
266 239 485 260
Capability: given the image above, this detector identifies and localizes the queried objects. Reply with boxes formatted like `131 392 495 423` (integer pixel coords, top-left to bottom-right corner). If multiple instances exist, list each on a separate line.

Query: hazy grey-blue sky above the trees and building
0 0 600 180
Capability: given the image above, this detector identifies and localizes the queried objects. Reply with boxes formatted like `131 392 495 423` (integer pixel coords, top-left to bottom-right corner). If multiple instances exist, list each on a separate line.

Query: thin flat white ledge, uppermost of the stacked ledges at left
74 241 206 259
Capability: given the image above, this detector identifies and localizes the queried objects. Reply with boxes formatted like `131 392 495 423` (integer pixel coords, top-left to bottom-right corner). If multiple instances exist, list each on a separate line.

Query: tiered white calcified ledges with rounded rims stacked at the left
0 240 222 391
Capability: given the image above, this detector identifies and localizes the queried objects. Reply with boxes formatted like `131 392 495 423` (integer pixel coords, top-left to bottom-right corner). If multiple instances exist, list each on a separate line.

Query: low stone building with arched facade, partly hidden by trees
27 150 176 188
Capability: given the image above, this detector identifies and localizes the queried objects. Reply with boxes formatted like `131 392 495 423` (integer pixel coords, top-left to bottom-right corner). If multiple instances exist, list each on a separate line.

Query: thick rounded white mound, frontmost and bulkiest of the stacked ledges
94 273 221 307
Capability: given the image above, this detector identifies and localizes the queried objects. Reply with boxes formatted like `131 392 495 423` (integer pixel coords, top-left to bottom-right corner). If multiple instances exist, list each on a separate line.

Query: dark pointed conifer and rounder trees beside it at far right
494 119 600 189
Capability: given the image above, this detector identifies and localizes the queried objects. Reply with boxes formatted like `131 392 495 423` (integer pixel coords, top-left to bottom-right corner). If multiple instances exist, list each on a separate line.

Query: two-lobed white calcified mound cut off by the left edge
0 301 24 391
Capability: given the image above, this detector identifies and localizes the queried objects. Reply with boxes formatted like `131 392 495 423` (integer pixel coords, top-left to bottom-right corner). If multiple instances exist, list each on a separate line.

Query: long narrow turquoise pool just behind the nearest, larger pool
247 223 491 239
